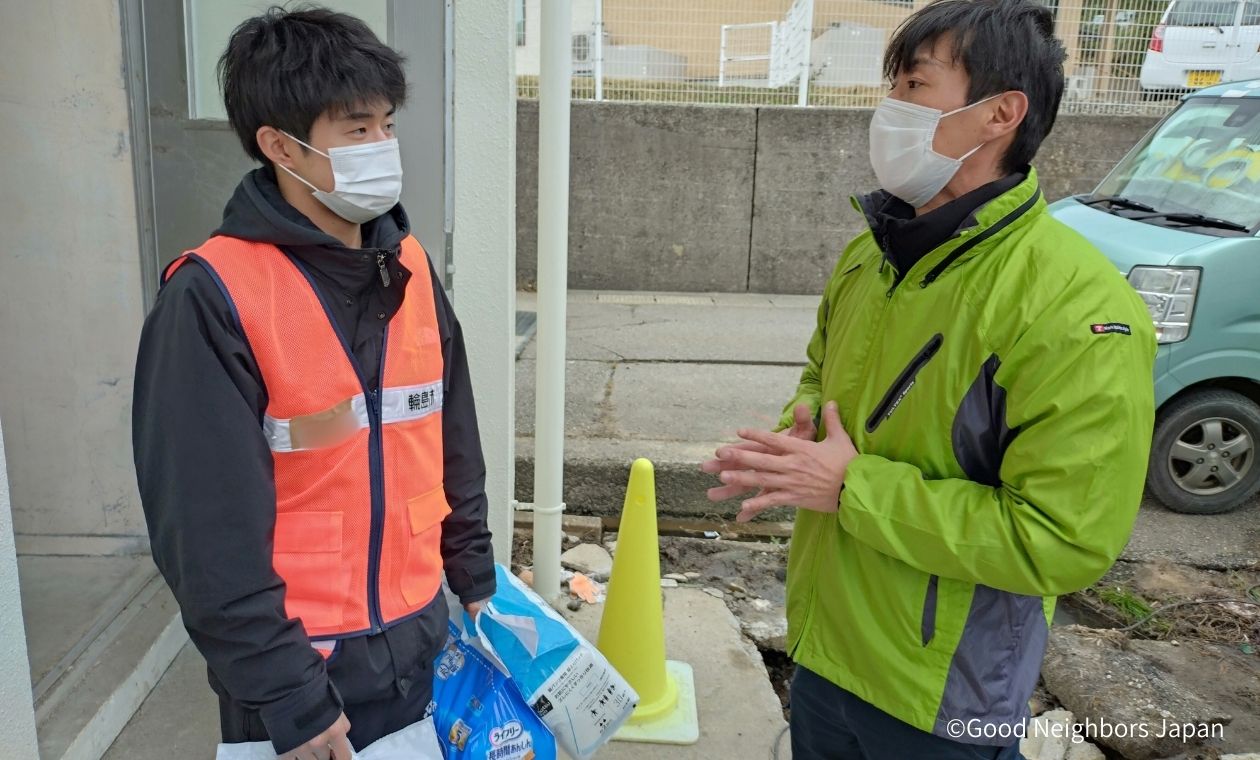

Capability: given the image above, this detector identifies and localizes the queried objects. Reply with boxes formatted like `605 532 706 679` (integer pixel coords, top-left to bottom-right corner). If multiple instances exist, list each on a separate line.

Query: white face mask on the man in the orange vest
277 132 402 224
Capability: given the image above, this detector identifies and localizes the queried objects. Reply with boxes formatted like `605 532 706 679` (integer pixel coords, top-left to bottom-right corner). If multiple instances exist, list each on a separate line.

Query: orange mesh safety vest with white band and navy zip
164 236 451 642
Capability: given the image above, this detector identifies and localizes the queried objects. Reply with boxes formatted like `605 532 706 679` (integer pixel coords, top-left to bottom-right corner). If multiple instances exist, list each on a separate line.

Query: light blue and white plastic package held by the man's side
454 565 639 760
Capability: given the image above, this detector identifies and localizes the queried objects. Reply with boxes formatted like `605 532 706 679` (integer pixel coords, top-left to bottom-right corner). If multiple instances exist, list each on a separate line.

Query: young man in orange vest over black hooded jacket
134 8 495 760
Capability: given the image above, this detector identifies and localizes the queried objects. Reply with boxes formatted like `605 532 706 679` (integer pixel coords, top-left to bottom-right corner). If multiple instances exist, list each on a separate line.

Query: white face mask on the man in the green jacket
871 96 998 208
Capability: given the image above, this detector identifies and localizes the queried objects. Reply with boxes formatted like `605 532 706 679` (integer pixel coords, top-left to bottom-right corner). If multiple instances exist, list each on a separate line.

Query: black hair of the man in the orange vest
218 5 407 164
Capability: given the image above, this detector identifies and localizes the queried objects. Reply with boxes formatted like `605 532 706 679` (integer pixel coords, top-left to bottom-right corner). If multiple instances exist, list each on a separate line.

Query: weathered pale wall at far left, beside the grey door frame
0 0 145 548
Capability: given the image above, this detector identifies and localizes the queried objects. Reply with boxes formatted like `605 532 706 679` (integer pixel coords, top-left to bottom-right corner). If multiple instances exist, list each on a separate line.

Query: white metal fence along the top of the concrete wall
517 0 1229 115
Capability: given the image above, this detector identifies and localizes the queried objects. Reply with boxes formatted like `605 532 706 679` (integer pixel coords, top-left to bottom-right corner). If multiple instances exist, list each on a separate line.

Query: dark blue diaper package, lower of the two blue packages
433 623 556 760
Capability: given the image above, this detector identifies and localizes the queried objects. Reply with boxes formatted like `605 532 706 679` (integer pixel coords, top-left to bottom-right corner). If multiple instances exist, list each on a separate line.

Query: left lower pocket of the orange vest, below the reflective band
272 512 350 630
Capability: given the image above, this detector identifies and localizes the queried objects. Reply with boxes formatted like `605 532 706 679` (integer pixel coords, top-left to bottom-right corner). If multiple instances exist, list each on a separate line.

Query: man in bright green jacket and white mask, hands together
703 0 1155 760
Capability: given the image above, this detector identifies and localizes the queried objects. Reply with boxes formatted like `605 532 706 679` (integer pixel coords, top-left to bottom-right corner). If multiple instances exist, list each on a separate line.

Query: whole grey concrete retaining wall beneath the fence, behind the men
517 101 1155 294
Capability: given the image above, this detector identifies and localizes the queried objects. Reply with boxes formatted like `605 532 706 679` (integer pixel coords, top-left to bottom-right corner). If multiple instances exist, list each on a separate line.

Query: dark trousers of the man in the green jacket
791 665 1023 760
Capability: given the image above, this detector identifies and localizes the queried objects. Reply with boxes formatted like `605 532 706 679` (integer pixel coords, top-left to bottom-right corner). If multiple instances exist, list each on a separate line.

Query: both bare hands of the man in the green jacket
703 401 858 522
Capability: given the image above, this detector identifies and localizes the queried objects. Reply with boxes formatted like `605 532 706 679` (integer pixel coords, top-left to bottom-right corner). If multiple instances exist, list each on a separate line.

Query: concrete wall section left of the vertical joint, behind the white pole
517 101 757 291
